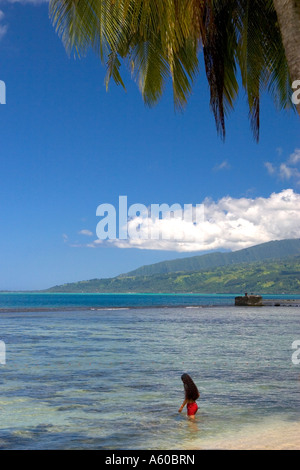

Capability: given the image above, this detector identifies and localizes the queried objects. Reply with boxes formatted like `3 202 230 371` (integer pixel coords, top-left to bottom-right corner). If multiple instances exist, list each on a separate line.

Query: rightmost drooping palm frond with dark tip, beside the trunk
237 0 291 140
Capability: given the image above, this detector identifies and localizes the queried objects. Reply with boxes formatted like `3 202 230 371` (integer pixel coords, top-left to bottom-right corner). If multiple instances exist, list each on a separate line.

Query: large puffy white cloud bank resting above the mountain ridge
85 189 300 252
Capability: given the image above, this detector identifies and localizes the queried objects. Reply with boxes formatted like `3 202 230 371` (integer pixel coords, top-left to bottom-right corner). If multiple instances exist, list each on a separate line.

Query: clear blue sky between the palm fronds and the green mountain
0 1 300 290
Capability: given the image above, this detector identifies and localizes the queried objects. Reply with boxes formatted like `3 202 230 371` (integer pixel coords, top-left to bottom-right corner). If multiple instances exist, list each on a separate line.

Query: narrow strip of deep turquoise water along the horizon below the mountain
0 292 300 313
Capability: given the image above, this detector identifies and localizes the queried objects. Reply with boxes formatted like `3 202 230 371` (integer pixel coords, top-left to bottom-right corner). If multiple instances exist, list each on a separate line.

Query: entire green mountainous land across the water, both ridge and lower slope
43 239 300 294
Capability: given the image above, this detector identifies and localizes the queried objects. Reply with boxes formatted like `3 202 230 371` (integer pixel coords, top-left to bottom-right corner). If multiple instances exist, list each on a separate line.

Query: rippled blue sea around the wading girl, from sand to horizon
0 294 300 450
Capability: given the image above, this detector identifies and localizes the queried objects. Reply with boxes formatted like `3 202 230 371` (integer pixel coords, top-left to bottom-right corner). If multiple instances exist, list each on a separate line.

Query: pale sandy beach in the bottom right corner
193 421 300 450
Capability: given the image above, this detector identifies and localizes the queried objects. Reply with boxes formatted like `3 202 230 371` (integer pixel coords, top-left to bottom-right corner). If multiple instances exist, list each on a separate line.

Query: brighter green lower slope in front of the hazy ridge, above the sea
48 256 300 294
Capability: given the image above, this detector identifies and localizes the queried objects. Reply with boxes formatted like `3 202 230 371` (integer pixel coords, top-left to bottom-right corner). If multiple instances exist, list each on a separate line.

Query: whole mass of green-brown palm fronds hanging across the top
49 0 300 139
